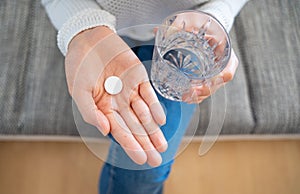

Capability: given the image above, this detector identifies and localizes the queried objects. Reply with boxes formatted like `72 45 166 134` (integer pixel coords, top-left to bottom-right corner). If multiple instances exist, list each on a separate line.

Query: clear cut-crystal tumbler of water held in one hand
150 11 231 101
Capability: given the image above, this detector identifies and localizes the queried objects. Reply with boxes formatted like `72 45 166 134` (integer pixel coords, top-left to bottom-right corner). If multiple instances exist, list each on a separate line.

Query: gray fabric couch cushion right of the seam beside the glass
234 0 300 133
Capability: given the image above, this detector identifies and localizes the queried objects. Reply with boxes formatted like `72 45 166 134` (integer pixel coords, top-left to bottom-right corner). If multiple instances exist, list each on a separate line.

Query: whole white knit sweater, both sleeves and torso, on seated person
42 0 248 55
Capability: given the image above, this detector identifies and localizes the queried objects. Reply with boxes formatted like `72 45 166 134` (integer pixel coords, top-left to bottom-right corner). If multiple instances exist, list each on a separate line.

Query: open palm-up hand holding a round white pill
65 26 167 166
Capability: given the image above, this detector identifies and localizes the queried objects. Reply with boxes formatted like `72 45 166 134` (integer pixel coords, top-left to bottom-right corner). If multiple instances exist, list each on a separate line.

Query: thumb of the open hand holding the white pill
72 90 110 135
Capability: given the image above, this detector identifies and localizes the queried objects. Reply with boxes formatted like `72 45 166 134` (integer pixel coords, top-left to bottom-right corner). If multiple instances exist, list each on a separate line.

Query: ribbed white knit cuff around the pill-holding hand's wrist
57 9 116 56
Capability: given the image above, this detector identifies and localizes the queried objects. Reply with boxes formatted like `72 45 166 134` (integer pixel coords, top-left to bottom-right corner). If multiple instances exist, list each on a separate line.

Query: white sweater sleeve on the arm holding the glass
198 0 248 32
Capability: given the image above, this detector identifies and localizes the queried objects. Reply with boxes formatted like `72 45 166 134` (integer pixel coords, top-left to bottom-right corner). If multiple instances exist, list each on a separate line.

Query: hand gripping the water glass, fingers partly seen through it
154 12 239 103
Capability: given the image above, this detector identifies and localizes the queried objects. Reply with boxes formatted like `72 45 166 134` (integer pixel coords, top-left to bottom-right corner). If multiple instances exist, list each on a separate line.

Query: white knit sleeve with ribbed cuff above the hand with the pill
41 0 116 55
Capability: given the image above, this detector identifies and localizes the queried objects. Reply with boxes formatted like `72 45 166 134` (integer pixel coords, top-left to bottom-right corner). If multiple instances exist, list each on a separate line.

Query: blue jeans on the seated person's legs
99 39 196 194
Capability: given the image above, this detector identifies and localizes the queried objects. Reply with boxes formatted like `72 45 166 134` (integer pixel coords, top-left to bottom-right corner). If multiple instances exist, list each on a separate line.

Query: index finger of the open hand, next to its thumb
107 112 147 165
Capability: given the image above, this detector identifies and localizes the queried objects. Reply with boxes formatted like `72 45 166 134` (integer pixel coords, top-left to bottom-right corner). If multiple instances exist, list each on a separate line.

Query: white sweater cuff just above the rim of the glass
198 1 234 32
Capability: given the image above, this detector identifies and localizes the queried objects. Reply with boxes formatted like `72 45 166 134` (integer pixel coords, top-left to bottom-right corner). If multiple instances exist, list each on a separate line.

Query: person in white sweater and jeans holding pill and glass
41 0 247 194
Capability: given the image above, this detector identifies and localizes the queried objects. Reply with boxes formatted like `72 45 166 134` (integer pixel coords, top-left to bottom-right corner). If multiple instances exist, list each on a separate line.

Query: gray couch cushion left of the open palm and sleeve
0 0 78 135
